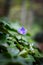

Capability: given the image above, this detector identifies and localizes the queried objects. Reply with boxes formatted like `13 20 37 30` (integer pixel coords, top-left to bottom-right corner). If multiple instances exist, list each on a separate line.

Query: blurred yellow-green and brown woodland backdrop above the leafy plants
0 0 43 30
